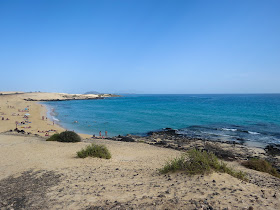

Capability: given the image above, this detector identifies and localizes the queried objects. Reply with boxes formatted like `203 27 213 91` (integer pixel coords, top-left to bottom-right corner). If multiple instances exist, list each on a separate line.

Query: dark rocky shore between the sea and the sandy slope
111 128 280 172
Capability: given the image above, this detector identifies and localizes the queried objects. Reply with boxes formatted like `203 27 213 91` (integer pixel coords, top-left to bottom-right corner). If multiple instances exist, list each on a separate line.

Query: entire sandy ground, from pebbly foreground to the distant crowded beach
0 93 280 209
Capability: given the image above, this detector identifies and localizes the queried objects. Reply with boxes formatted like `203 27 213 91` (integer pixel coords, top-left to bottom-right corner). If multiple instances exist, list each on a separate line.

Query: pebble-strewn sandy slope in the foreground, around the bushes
0 135 280 209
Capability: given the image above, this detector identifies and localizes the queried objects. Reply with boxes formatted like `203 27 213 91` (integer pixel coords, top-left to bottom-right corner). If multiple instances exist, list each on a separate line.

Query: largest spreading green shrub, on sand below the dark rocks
159 149 246 180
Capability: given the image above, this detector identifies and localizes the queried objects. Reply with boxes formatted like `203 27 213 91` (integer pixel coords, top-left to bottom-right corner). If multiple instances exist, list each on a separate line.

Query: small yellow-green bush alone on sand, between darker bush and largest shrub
77 144 111 159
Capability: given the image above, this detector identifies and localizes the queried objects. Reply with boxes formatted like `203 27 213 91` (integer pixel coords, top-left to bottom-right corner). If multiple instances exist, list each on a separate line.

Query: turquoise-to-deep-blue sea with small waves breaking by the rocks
44 94 280 144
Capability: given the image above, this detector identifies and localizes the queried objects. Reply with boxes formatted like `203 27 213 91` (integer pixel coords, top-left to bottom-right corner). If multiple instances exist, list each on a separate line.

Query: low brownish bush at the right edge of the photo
242 159 280 178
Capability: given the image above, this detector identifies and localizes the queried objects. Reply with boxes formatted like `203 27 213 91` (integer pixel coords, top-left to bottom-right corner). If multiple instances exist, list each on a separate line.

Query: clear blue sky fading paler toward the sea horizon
0 0 280 94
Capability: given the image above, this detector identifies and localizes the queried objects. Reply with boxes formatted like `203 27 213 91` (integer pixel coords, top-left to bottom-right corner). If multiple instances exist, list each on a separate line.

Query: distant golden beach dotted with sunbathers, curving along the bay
0 93 93 137
